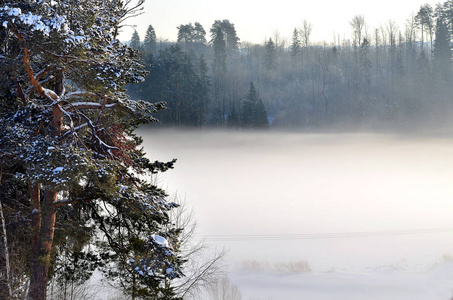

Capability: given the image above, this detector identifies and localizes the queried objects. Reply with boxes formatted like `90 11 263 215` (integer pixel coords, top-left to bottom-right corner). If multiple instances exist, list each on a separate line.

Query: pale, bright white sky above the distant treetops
120 0 445 43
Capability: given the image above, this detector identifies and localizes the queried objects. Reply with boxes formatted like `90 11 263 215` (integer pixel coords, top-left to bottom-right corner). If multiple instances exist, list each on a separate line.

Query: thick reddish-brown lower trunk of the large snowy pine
27 191 58 300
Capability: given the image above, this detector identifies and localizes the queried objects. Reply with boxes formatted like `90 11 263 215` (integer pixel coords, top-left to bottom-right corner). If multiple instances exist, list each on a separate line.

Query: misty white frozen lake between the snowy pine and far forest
139 127 453 299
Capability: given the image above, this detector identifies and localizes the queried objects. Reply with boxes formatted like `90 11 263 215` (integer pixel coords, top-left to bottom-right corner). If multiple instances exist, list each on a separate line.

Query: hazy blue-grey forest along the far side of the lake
127 0 453 128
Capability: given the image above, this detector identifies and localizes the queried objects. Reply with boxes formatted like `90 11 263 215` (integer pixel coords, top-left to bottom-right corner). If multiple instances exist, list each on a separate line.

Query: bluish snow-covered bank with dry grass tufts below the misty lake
230 262 453 300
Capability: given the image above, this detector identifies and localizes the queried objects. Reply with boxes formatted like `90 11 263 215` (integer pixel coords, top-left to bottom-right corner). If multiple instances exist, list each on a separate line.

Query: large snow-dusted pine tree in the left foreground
0 0 182 299
